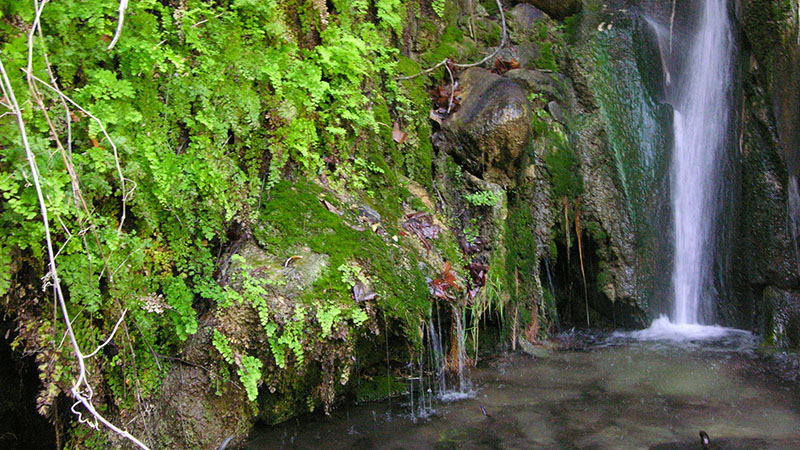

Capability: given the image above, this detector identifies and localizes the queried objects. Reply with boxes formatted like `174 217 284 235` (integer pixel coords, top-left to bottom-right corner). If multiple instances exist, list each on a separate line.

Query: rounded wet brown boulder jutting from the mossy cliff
442 67 532 186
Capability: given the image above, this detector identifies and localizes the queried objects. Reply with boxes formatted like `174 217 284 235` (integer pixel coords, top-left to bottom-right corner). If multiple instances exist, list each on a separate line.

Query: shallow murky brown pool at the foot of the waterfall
247 336 800 450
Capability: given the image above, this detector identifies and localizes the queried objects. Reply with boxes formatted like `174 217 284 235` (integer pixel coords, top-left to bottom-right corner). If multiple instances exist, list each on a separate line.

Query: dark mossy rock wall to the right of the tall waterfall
736 0 800 349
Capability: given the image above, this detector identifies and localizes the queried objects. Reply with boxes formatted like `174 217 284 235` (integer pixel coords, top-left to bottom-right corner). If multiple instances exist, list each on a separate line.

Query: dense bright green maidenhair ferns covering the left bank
0 0 422 426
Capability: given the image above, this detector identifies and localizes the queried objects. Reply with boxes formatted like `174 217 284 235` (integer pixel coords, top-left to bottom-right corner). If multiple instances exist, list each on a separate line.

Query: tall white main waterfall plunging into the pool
671 0 733 324
